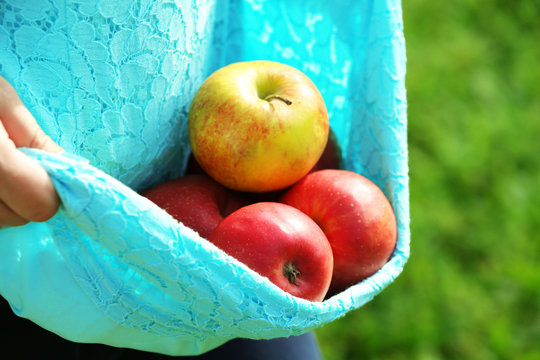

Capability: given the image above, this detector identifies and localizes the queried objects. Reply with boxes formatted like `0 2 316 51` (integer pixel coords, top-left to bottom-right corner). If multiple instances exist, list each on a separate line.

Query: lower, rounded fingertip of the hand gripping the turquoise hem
0 123 60 222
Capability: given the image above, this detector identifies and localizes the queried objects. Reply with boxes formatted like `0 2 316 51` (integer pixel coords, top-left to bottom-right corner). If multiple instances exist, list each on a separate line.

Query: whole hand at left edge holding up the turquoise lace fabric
0 76 62 227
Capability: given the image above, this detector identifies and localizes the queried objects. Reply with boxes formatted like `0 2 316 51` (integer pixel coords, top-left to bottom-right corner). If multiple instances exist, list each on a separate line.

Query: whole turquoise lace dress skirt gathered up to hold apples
0 0 410 355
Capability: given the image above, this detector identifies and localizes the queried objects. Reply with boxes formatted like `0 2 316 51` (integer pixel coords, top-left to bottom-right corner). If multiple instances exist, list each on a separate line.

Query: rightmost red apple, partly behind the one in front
280 169 397 294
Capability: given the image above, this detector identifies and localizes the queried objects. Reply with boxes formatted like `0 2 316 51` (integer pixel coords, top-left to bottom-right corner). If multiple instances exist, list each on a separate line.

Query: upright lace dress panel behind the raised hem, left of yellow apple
0 0 224 188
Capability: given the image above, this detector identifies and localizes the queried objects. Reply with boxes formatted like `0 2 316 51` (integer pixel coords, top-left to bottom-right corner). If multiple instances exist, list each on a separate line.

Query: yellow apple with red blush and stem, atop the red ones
188 61 329 192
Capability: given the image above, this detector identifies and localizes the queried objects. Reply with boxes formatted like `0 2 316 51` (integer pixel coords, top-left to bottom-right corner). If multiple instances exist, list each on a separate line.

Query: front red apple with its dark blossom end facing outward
208 202 333 301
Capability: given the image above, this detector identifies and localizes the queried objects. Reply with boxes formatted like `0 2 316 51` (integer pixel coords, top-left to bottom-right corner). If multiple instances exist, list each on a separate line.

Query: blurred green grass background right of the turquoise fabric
316 0 540 360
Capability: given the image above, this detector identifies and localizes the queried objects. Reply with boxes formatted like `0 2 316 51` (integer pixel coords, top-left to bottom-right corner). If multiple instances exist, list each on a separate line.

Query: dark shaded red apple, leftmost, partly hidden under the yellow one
141 174 247 239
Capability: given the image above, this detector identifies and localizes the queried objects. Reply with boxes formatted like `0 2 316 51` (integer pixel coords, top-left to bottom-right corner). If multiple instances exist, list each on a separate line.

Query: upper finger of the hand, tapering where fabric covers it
0 76 62 153
